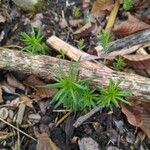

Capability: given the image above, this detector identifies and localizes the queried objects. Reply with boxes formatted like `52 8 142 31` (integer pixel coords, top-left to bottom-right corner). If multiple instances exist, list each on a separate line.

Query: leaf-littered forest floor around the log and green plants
0 0 150 150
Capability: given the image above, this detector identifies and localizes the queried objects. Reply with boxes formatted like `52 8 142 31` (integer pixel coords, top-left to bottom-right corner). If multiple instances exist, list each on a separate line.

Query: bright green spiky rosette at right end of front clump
98 80 131 108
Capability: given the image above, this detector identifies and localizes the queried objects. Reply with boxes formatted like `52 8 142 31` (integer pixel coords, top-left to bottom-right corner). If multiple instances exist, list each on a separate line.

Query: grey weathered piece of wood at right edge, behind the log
97 29 150 52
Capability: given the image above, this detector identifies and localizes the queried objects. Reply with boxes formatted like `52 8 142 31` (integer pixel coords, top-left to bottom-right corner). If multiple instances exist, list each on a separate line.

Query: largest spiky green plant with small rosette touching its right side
42 64 97 111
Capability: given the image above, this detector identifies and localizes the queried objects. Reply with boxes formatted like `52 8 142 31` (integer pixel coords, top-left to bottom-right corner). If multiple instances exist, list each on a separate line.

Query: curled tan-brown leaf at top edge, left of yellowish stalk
91 0 114 17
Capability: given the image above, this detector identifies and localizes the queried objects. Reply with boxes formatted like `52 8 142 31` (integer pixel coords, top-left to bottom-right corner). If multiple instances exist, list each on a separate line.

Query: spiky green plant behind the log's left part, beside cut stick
21 28 48 55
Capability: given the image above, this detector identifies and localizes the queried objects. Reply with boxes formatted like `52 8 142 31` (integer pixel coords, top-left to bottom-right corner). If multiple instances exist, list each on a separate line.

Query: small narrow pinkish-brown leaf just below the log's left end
6 74 25 91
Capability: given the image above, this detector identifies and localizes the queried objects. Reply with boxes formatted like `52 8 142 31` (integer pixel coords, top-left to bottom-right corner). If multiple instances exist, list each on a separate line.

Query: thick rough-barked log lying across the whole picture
0 49 150 101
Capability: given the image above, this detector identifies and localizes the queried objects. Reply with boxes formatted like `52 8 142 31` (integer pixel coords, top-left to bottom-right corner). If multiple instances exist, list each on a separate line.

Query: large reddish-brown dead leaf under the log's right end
121 97 150 138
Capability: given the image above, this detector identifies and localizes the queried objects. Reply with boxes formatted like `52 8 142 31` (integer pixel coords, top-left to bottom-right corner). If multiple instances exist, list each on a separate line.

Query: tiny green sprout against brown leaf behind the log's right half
113 56 125 70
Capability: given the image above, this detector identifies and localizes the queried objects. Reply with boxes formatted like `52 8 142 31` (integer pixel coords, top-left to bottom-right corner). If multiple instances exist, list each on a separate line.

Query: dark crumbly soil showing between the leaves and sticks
0 0 150 150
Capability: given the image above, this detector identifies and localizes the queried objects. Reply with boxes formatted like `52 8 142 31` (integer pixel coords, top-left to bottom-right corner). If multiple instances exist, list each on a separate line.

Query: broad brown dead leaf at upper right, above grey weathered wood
113 13 150 36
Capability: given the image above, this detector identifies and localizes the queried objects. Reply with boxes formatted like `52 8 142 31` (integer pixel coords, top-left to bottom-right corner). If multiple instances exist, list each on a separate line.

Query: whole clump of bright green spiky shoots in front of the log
41 63 131 112
